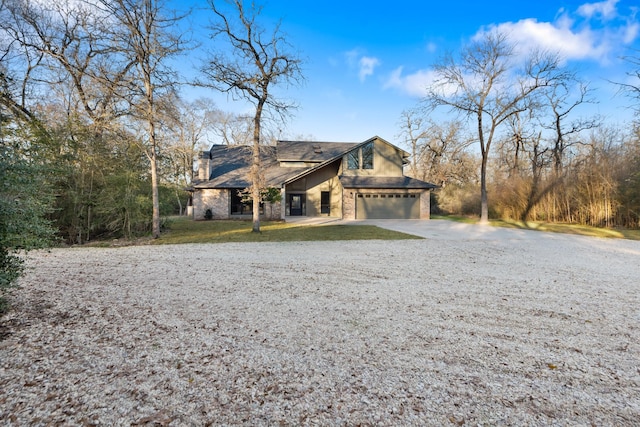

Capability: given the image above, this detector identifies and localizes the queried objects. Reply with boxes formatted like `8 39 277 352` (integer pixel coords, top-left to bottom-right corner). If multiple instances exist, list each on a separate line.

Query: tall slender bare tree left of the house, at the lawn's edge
99 0 187 238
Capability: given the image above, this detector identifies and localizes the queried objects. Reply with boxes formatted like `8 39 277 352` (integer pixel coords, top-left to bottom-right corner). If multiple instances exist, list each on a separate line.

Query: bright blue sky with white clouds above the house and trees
179 0 640 142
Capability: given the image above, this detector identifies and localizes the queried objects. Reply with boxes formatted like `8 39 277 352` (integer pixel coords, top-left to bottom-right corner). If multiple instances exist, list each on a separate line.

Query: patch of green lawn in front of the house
151 217 420 245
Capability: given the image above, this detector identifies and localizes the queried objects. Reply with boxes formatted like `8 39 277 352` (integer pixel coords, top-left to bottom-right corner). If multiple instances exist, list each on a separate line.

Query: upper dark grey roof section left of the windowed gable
278 141 361 163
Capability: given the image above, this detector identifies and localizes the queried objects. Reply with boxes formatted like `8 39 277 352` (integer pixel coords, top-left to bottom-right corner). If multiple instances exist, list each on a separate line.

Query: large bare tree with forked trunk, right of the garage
424 32 559 223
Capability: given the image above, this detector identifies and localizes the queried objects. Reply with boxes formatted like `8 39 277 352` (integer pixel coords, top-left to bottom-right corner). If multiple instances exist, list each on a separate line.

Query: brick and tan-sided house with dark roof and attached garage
192 136 436 220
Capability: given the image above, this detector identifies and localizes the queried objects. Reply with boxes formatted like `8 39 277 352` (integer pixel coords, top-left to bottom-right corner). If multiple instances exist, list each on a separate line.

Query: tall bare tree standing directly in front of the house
201 0 302 232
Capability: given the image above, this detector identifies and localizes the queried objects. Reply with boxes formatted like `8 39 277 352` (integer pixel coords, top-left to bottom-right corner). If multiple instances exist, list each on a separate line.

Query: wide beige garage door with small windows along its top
356 193 420 219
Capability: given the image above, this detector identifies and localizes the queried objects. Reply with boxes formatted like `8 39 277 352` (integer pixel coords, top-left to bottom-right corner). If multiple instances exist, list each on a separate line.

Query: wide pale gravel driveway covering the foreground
0 220 640 426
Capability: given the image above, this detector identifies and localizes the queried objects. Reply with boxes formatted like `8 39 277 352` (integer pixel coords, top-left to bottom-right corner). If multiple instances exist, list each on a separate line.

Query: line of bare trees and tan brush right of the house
400 32 640 228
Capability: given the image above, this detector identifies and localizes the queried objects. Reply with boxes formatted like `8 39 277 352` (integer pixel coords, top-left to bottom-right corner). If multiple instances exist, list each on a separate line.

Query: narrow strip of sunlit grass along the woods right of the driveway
432 215 640 240
